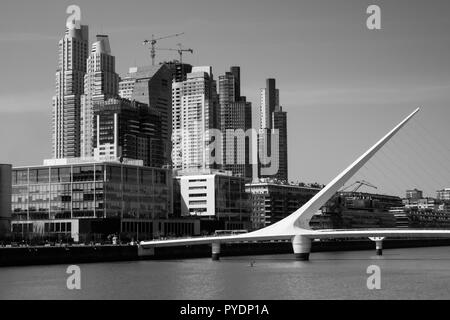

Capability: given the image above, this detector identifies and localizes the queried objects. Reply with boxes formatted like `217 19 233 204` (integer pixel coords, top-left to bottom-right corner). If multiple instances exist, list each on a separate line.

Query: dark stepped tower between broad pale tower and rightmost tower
219 67 256 178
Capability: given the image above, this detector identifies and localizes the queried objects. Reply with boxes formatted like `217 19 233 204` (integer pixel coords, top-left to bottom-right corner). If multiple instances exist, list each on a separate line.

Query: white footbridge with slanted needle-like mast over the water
139 108 450 260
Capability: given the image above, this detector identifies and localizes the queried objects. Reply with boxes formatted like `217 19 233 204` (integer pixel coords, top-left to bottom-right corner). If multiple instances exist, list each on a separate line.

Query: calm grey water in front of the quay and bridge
0 247 450 300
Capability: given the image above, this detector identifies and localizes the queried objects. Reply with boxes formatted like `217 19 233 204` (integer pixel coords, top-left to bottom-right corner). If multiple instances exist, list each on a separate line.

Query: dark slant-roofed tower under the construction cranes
119 64 172 165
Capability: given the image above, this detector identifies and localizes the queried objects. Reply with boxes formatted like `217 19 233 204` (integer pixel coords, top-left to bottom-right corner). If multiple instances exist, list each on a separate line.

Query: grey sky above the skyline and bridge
0 0 450 196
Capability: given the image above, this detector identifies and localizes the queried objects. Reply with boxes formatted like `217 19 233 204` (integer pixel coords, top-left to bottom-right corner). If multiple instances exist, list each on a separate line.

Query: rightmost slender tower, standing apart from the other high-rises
258 79 288 181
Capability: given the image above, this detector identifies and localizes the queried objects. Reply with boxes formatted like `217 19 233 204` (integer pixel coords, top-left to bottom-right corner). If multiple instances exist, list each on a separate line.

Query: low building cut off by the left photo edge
0 164 12 237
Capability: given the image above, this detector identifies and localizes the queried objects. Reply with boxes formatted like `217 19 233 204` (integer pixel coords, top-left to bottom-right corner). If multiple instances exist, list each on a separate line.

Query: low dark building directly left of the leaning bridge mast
245 181 320 229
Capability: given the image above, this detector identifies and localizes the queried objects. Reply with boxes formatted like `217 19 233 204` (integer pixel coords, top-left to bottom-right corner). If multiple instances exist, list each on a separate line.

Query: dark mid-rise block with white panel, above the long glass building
93 99 165 168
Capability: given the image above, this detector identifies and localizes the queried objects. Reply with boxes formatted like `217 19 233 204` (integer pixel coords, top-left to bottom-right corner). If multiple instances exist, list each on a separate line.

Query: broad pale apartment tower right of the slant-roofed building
172 67 219 170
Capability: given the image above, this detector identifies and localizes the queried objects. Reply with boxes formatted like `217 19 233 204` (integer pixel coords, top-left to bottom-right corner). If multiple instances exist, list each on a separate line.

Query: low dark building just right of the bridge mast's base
310 192 402 229
